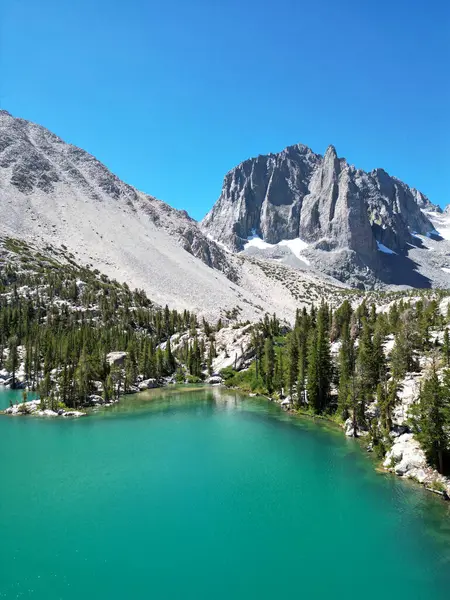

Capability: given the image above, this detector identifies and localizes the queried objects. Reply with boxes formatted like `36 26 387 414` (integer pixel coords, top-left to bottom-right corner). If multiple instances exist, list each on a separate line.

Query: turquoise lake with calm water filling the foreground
0 389 450 600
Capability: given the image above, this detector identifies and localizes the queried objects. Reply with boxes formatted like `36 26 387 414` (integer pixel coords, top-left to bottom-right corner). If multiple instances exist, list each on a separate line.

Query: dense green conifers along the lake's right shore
225 298 450 471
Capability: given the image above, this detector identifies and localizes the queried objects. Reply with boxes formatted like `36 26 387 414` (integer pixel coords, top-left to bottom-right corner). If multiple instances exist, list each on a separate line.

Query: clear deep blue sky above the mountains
0 0 450 218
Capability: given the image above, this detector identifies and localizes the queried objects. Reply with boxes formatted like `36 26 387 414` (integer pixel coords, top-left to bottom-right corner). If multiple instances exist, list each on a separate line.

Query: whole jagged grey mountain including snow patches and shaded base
202 145 448 287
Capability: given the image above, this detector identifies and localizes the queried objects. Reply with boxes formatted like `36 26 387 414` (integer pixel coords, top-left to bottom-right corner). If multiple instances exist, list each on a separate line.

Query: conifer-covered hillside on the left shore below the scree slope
0 251 215 408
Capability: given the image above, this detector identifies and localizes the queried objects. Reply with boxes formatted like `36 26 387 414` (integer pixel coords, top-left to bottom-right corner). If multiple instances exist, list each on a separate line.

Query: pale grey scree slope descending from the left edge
0 111 352 320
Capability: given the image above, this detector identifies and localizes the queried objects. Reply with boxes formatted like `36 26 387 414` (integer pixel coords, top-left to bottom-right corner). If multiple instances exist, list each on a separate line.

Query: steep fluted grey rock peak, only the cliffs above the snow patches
202 144 437 266
